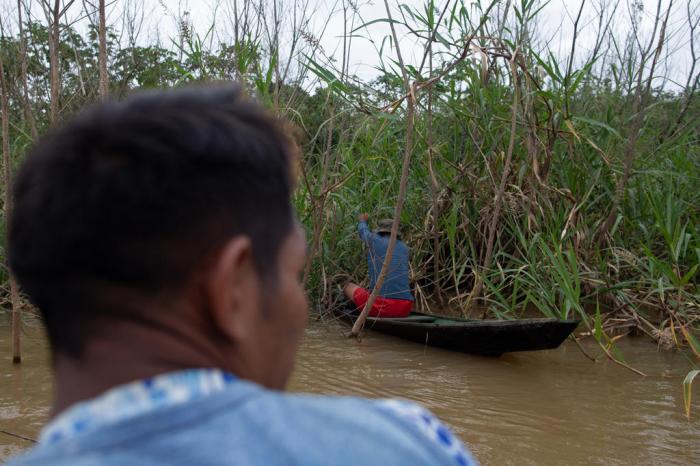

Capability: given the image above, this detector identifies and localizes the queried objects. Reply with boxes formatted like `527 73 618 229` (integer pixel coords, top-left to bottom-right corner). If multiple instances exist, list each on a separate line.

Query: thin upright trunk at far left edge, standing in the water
0 38 22 364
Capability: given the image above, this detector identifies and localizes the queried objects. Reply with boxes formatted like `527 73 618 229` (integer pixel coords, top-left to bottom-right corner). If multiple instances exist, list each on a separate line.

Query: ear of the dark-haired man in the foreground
205 236 258 341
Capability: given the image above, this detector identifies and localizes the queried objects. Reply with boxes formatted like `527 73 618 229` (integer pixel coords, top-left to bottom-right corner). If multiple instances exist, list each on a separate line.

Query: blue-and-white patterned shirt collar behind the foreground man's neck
39 369 236 445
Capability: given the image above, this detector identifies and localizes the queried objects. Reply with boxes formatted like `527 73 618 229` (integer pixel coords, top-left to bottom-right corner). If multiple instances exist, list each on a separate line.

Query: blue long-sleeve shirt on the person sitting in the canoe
357 221 413 301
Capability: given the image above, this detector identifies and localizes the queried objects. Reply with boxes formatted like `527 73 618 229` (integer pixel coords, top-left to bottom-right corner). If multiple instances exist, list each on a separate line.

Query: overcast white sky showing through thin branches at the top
0 0 700 88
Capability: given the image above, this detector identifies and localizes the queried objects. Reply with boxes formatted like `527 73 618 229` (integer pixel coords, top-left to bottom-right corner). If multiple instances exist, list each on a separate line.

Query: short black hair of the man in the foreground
9 85 295 356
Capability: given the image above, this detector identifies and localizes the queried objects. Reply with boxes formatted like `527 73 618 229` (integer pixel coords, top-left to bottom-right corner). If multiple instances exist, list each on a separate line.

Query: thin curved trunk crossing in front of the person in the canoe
351 0 415 337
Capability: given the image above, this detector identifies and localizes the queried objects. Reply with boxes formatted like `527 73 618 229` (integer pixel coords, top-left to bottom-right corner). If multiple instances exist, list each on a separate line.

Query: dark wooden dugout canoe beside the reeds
335 309 580 356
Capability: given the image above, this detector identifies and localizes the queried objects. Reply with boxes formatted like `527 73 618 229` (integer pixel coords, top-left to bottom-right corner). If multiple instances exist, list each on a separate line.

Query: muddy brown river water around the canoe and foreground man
0 315 700 465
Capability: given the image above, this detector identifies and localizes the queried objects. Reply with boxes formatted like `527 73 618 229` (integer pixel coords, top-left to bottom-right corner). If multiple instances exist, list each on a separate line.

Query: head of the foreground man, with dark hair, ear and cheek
9 87 306 386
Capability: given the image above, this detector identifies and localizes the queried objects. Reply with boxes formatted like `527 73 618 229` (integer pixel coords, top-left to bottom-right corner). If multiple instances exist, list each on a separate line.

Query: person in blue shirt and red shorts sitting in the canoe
343 214 413 317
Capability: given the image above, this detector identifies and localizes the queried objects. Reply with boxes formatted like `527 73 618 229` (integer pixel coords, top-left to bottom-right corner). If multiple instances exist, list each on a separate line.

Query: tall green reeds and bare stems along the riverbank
0 0 700 388
